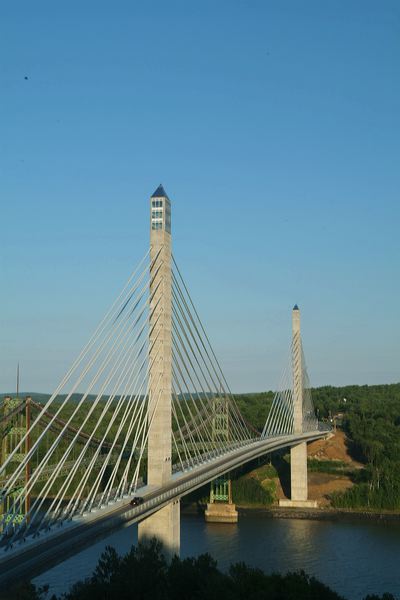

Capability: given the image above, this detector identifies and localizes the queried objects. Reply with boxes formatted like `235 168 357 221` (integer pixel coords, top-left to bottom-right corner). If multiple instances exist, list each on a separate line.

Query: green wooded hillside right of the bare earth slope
300 383 400 510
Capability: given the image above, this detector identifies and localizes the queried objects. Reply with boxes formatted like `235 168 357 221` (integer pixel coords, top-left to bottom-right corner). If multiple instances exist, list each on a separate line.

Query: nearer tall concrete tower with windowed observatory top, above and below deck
139 185 180 555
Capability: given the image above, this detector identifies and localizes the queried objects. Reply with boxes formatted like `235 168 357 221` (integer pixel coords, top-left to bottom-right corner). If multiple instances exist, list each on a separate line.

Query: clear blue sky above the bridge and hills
0 0 400 392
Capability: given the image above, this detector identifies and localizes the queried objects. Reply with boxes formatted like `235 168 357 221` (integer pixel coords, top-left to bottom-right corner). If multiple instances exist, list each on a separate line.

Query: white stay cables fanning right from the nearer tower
172 259 255 469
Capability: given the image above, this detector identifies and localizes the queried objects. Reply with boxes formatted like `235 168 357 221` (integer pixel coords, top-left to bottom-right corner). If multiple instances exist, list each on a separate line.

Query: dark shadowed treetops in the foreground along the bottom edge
9 540 395 600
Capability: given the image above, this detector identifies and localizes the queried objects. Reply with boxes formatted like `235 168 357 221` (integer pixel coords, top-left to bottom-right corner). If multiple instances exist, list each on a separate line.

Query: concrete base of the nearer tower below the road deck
138 500 181 559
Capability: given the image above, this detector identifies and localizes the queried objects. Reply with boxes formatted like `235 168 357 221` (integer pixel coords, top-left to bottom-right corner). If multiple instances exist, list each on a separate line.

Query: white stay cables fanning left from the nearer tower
0 253 159 535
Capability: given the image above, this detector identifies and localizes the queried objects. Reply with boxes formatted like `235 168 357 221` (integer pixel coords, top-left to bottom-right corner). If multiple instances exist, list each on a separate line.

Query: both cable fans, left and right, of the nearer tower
0 246 255 543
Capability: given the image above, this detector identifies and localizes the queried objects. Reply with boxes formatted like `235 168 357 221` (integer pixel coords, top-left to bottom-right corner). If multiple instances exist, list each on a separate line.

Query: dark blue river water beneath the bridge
34 511 400 600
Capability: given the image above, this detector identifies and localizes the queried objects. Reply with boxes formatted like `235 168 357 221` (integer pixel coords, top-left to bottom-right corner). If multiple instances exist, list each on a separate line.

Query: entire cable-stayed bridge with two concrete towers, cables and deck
0 186 326 586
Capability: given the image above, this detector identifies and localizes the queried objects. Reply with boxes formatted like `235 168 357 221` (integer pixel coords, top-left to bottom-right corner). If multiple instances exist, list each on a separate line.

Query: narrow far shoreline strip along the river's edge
181 503 400 523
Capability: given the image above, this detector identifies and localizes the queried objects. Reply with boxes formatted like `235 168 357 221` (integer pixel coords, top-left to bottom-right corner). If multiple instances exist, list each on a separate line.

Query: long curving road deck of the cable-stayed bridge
0 431 327 589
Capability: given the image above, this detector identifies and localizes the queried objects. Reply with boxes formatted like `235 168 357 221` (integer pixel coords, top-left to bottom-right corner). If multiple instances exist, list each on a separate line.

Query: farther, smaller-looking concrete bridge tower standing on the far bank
279 304 317 508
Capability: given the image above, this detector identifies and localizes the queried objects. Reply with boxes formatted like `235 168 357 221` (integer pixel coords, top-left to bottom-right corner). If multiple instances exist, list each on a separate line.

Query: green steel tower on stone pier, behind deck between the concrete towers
205 395 238 523
